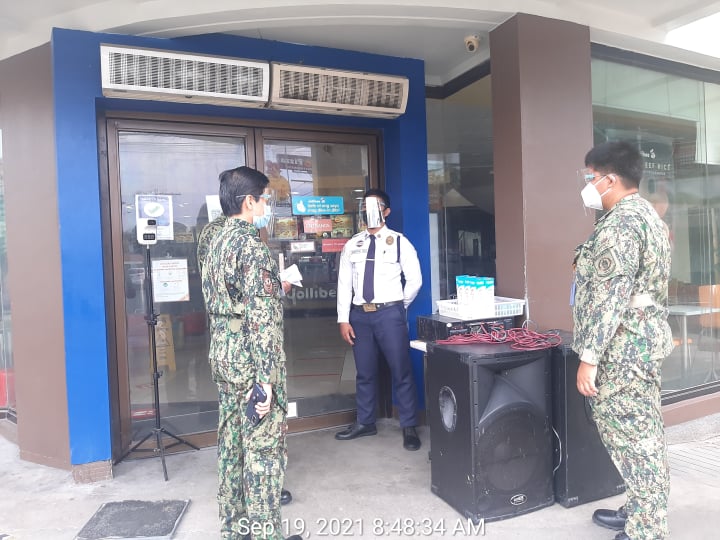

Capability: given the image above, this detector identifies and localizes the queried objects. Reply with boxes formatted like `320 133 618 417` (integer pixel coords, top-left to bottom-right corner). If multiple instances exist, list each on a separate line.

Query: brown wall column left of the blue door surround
0 45 70 468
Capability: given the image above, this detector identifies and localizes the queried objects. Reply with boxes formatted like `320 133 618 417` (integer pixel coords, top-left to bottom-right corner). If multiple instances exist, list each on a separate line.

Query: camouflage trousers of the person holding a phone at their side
218 382 287 540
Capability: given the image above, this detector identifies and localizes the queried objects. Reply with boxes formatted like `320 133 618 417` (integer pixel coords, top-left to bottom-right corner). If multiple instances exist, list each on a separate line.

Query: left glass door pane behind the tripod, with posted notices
114 126 247 446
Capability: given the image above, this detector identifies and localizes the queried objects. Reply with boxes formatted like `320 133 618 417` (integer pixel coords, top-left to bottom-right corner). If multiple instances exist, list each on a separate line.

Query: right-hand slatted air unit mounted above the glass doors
270 62 409 118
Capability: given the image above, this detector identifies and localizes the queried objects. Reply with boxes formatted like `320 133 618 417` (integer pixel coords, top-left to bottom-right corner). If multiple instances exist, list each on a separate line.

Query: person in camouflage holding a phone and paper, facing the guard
200 167 297 540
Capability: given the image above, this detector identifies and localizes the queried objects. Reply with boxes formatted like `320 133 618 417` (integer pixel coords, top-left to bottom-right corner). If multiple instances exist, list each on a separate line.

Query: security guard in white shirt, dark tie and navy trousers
335 189 422 450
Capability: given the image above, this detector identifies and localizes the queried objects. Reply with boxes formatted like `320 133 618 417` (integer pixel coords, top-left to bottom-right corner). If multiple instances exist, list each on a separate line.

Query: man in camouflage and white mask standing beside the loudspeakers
573 142 673 540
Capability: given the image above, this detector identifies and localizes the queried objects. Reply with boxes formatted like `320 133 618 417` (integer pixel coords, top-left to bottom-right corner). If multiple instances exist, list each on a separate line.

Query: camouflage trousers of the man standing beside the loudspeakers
591 358 670 540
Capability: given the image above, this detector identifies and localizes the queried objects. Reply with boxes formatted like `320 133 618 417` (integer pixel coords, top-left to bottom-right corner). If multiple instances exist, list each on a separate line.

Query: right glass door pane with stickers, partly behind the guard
262 133 377 418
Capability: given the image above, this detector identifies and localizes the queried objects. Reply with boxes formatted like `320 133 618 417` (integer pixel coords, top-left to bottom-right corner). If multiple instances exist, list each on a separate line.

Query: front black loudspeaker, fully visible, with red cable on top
426 343 554 522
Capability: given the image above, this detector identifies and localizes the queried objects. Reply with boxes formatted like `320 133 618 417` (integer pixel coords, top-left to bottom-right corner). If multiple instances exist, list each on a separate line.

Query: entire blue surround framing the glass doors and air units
52 29 432 464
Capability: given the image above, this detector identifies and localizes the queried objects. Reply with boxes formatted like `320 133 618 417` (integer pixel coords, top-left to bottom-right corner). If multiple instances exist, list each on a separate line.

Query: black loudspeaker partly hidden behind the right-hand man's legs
552 331 625 508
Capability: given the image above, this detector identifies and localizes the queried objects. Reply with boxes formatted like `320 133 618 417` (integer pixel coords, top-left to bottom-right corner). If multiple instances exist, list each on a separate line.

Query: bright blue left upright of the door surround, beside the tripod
52 28 110 465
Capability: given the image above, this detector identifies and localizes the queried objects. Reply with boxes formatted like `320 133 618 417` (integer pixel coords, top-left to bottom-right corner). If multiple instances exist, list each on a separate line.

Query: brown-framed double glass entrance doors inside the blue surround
107 119 379 457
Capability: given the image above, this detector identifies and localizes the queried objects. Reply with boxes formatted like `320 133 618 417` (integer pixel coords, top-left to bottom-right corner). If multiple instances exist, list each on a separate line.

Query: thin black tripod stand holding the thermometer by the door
122 245 199 481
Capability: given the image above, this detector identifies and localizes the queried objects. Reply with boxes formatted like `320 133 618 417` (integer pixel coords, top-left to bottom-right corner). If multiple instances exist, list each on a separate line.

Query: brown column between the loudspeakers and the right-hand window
490 14 593 330
